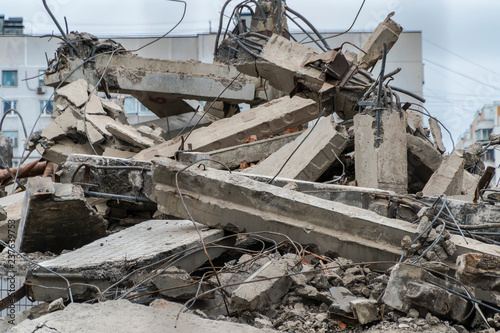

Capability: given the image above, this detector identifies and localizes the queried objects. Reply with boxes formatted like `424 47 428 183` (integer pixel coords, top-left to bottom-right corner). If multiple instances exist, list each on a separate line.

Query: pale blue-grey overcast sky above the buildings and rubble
1 0 500 147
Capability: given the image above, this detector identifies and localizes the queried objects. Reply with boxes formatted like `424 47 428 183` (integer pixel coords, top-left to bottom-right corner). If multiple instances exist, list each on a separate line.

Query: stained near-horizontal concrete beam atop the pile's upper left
45 54 255 118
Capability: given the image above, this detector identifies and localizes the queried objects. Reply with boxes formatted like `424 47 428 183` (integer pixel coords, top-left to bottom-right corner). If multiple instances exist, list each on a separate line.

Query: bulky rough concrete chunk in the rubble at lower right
382 264 470 322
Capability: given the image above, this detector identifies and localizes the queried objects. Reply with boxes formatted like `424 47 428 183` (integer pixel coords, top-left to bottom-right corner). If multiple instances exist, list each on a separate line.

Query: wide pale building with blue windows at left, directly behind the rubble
0 16 423 165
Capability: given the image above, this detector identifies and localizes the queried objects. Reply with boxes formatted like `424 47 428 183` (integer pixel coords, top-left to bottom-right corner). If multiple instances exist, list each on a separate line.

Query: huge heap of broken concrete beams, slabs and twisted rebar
0 0 500 332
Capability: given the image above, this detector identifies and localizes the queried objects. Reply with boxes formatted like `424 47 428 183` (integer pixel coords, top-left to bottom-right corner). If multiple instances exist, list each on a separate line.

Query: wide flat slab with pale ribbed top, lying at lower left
27 220 230 301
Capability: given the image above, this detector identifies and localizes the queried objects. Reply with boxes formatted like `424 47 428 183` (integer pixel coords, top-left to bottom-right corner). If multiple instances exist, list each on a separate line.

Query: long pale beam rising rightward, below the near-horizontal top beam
134 96 319 161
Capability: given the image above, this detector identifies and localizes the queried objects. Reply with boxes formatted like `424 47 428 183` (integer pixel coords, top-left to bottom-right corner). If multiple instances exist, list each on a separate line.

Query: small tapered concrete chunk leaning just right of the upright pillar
422 152 465 196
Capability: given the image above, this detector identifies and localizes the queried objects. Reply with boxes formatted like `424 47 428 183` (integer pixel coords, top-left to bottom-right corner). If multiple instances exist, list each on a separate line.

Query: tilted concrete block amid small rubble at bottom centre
230 254 300 311
